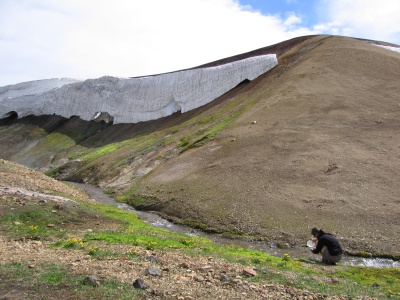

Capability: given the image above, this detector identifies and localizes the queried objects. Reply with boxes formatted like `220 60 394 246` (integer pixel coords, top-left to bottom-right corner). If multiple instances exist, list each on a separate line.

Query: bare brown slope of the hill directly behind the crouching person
138 36 400 254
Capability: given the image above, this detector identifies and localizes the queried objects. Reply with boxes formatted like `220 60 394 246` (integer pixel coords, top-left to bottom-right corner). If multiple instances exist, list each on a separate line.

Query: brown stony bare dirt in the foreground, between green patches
0 160 376 300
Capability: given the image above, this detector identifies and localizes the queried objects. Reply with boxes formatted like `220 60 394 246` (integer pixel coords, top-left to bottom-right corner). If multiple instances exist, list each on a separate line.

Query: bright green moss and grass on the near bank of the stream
0 193 400 299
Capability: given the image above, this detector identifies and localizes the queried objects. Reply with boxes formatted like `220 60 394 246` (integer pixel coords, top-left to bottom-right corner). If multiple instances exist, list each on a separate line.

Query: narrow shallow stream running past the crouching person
66 182 400 268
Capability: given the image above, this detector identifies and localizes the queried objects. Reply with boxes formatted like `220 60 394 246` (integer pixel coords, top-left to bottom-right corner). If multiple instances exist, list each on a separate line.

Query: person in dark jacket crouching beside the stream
311 227 343 265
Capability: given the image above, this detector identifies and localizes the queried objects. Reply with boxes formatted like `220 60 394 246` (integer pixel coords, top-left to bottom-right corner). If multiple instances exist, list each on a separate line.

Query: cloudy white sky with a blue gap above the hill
0 0 400 86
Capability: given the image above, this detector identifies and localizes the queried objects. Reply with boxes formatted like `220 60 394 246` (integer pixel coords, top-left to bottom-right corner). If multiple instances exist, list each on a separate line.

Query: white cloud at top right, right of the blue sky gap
314 0 400 44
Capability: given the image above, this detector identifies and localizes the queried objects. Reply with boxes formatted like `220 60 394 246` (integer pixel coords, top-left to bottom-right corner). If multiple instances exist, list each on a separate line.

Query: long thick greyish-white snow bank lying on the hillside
0 54 278 124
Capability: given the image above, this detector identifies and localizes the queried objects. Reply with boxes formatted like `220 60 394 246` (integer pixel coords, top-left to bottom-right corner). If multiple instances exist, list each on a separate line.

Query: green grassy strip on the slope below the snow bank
43 83 265 190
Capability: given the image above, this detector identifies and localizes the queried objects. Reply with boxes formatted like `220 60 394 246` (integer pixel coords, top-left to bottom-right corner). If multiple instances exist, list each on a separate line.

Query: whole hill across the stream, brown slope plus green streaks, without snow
0 36 400 257
